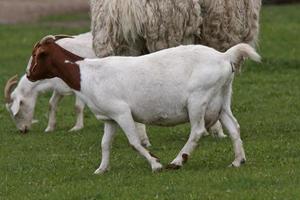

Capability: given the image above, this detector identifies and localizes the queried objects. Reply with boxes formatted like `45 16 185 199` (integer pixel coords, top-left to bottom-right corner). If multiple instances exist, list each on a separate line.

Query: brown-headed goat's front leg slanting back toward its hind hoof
115 111 162 172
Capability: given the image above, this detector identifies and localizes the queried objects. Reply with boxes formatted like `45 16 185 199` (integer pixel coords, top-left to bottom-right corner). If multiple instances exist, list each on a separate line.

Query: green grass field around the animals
0 4 300 200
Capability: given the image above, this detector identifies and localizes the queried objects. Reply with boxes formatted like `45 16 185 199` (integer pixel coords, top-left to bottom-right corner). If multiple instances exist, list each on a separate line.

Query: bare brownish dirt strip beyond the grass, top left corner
0 0 89 24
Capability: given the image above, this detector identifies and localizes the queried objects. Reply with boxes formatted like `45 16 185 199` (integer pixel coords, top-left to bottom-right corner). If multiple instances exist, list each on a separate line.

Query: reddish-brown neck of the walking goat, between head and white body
52 45 83 91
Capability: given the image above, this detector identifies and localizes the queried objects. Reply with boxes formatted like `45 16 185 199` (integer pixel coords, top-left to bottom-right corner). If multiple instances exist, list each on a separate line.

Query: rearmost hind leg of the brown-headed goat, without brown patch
221 108 246 167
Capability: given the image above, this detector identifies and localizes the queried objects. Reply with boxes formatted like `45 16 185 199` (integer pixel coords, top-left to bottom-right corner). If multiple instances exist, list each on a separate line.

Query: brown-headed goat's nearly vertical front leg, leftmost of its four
94 121 117 174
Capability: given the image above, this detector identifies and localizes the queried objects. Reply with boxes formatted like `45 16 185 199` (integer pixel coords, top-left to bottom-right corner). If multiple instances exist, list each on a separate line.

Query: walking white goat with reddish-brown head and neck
26 36 260 174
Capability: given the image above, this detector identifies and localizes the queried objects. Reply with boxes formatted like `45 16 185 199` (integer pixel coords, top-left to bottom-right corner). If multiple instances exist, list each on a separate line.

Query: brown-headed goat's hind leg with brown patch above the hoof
167 102 206 169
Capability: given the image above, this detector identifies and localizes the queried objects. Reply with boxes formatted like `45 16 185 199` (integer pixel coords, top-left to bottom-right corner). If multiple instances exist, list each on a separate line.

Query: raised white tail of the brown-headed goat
224 43 261 70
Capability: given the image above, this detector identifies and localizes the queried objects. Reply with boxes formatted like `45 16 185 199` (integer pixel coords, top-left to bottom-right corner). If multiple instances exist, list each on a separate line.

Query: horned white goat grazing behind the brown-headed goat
5 32 96 132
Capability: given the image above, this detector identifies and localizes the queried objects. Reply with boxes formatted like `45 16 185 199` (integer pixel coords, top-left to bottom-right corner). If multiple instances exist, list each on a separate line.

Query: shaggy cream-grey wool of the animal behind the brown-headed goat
91 0 261 57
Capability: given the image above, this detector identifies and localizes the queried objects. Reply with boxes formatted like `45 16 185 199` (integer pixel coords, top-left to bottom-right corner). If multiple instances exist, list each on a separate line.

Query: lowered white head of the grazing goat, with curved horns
4 76 36 133
